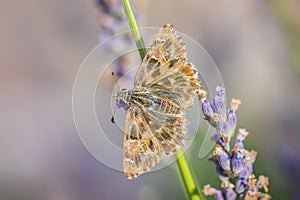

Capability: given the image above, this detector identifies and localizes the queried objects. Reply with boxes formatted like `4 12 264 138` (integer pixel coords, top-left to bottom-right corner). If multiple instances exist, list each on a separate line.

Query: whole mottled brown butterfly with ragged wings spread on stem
114 24 201 179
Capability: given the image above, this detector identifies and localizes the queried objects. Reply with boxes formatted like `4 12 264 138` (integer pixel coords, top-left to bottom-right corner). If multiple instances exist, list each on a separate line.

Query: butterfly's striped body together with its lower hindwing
131 86 188 154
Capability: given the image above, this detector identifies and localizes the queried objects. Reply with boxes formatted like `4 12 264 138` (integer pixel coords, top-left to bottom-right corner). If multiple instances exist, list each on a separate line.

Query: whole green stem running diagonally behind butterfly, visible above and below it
122 0 201 200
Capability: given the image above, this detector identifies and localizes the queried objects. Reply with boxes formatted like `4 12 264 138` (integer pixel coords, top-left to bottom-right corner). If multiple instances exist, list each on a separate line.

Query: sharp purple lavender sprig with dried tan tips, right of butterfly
199 86 271 200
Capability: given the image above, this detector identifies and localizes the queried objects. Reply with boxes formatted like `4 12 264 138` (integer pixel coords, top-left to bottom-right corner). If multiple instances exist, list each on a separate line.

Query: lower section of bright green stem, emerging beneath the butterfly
176 148 201 200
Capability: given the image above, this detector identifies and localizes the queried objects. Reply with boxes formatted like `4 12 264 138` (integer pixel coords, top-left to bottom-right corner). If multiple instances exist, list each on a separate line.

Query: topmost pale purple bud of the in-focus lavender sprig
212 86 226 119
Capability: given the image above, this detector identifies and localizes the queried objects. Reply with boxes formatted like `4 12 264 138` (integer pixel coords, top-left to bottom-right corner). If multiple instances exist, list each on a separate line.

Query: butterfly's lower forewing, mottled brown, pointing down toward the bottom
123 106 162 179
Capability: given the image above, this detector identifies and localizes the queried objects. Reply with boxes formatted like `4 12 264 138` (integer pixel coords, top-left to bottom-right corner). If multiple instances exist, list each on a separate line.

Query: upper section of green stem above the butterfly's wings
122 0 146 60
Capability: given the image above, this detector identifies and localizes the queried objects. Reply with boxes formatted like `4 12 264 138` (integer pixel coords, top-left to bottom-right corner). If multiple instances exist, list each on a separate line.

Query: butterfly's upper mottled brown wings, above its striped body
134 24 200 109
